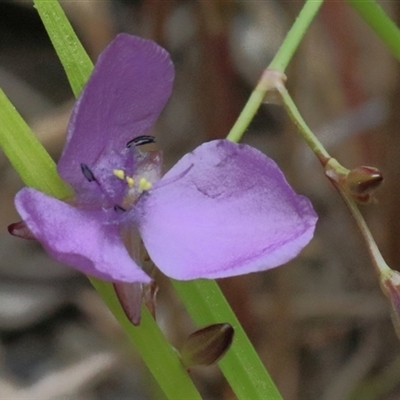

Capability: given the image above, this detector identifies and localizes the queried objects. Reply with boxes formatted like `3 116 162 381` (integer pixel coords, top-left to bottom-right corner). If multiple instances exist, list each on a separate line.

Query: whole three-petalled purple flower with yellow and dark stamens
15 34 317 283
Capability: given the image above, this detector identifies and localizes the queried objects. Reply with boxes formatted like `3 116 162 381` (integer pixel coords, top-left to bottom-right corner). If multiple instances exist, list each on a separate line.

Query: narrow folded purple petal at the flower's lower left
15 188 151 283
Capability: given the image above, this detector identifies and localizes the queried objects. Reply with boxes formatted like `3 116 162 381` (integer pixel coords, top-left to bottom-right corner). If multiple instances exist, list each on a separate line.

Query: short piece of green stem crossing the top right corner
347 0 400 60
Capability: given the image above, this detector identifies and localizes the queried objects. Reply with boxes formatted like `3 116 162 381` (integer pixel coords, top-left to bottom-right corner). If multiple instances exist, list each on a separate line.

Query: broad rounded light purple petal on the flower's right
136 140 317 280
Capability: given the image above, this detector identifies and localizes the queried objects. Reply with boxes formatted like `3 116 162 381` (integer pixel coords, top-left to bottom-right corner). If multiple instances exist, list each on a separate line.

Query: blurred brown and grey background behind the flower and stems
0 0 400 400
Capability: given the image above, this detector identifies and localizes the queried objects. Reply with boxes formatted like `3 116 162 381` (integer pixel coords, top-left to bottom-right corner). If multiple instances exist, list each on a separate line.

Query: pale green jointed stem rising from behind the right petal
226 0 323 142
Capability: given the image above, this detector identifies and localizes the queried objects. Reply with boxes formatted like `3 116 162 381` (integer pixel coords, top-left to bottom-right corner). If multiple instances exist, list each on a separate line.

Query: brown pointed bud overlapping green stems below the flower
181 323 234 367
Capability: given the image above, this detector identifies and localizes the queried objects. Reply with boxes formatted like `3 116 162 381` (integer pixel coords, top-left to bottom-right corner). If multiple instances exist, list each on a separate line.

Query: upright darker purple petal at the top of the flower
58 34 174 189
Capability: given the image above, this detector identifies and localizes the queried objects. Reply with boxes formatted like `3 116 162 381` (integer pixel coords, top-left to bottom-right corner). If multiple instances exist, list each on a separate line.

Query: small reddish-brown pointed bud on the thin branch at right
345 166 383 202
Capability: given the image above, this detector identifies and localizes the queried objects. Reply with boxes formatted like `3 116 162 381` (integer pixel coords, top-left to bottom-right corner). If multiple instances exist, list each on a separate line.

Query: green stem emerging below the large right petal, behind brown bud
171 280 282 400
